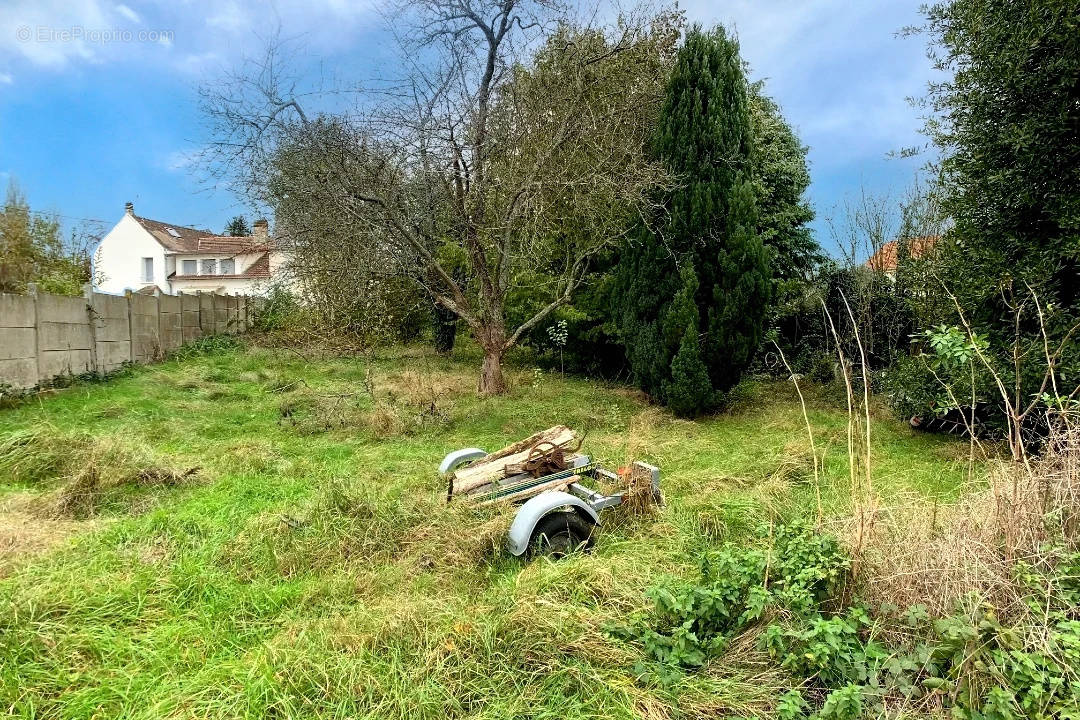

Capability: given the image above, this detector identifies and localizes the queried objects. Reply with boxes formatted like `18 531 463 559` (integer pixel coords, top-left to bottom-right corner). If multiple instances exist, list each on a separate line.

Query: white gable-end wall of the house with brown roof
94 215 170 295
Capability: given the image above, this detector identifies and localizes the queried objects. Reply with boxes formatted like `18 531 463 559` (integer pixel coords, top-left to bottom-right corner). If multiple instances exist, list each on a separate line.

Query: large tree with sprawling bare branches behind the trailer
203 0 683 394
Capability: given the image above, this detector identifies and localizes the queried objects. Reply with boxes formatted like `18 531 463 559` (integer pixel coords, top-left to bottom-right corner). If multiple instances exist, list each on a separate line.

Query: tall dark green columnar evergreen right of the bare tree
618 28 770 416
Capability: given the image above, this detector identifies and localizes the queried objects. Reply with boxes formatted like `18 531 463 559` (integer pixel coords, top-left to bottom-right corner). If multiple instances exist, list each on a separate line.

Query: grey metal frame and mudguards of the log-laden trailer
438 448 660 557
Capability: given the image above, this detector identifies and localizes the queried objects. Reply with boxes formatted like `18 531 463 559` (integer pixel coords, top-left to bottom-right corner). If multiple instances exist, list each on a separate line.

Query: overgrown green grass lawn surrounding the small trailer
0 347 968 719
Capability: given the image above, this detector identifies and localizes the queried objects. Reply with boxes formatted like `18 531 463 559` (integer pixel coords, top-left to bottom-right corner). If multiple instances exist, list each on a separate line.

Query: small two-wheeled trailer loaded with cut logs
438 425 661 557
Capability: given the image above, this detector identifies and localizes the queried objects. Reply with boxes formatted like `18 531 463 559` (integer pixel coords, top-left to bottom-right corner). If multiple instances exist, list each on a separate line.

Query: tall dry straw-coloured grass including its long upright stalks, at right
812 284 1080 619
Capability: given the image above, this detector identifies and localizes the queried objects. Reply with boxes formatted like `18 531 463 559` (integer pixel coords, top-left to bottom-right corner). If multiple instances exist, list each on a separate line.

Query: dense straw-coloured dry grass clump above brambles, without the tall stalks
861 417 1080 620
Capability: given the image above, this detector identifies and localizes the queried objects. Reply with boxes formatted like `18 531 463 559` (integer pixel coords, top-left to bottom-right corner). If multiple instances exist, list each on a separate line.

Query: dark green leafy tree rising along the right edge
898 0 1080 433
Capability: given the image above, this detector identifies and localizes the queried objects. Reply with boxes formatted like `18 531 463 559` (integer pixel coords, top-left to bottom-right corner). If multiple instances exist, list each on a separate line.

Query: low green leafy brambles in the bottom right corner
607 522 1080 720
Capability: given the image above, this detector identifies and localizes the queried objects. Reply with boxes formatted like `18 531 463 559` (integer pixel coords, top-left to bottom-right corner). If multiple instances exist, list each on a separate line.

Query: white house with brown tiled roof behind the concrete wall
93 203 283 295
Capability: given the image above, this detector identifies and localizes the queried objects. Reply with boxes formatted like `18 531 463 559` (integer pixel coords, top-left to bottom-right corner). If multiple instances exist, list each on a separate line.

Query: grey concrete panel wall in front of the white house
0 286 258 390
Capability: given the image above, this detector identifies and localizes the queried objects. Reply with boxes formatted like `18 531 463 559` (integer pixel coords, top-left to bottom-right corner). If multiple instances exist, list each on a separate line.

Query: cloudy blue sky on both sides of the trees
0 0 933 253
